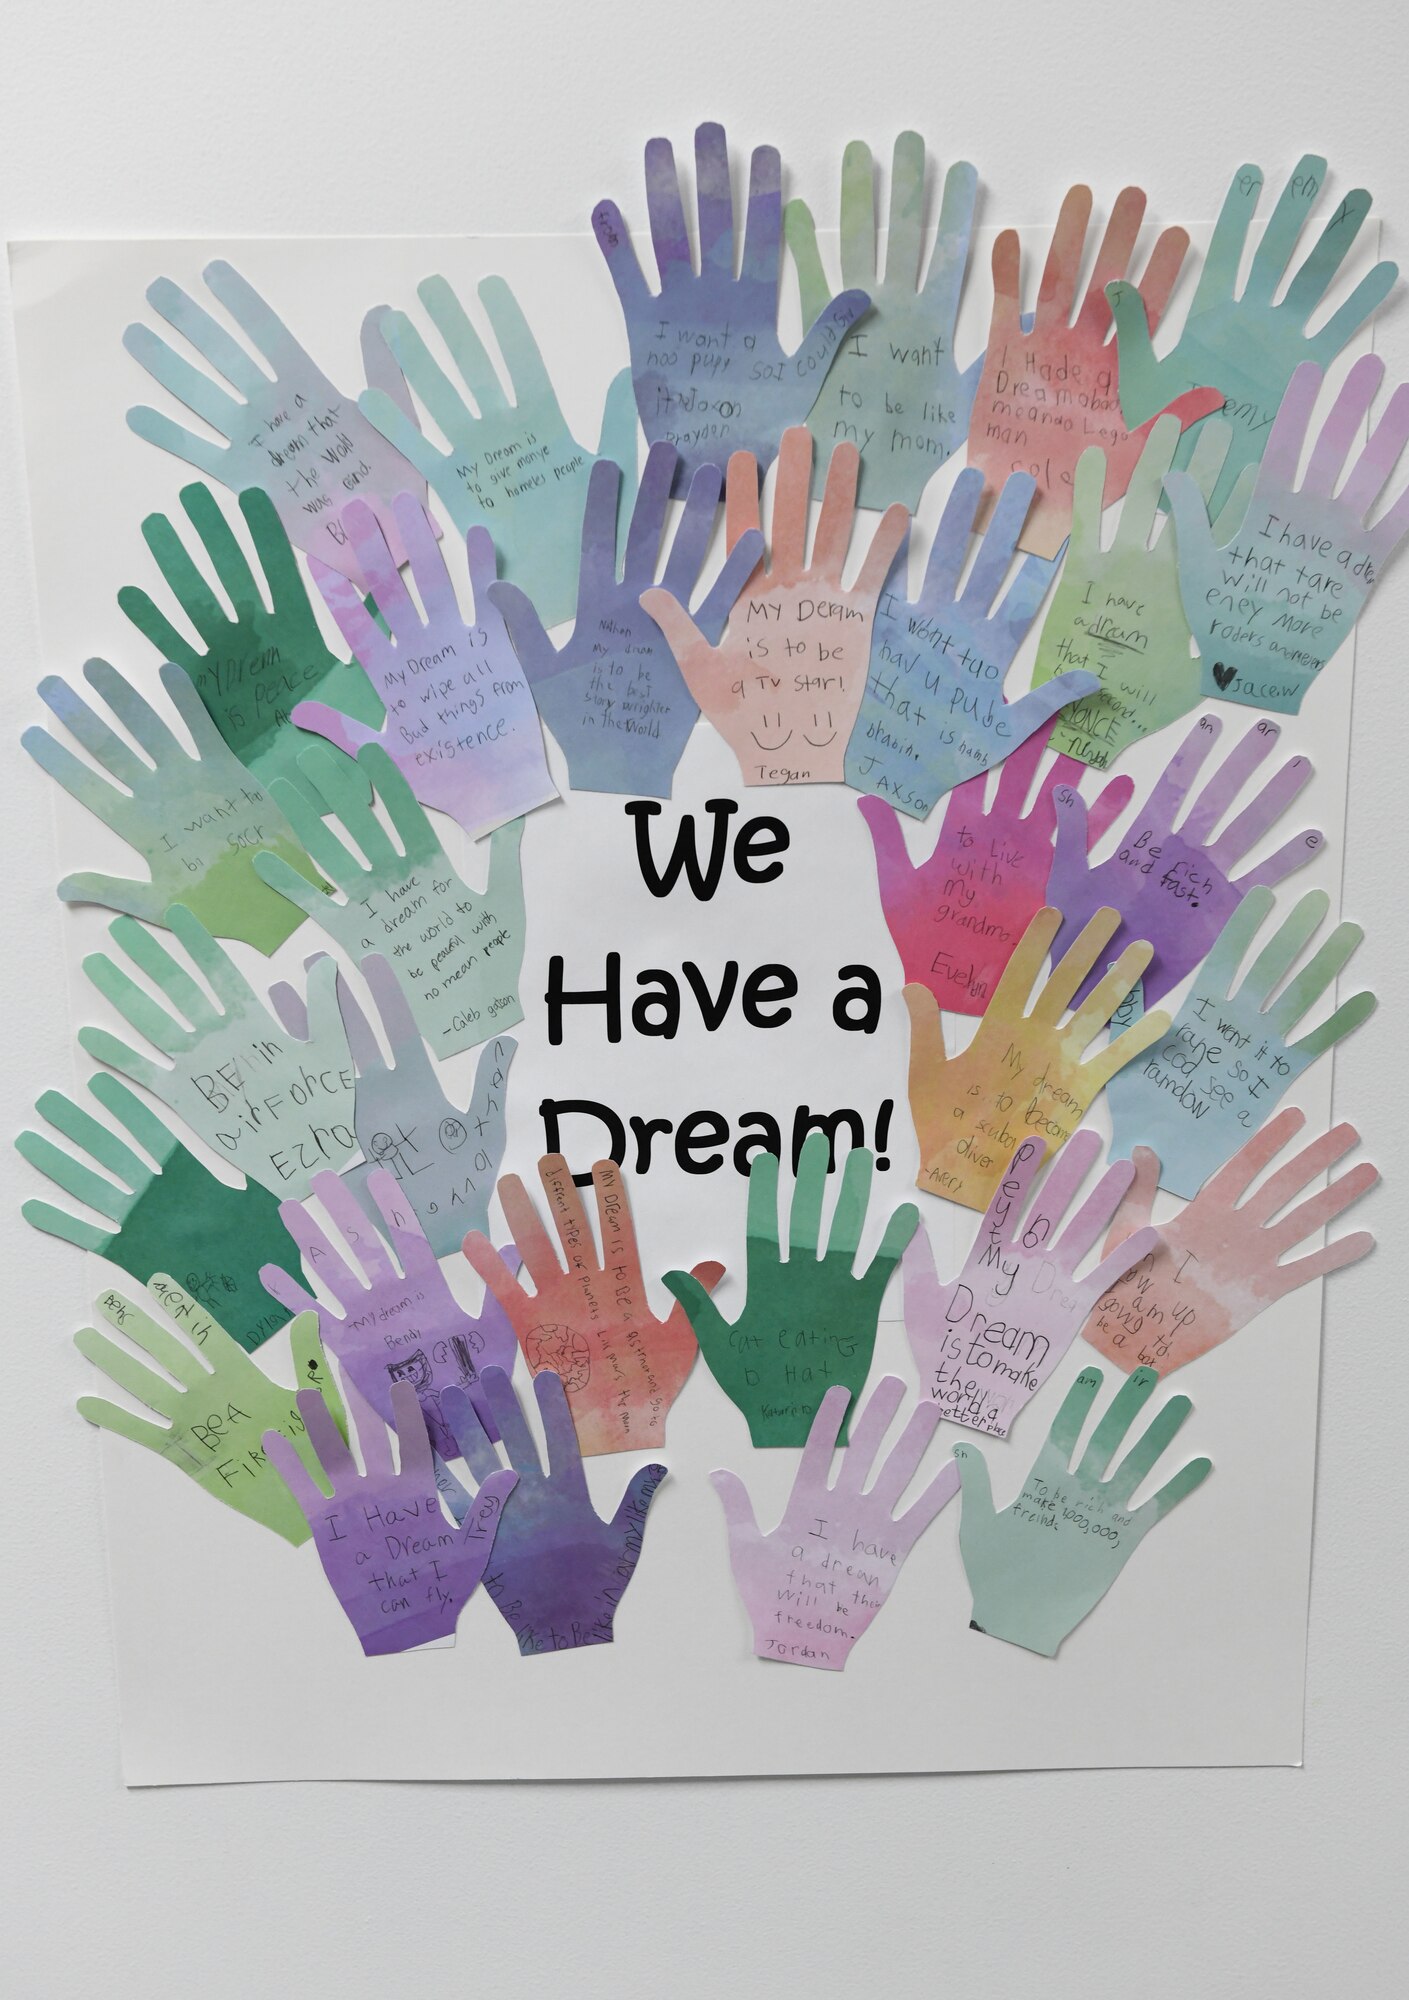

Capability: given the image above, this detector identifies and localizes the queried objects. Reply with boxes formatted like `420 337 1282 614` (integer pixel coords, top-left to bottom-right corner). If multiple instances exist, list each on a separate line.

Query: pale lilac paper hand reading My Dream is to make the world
901 1132 1159 1438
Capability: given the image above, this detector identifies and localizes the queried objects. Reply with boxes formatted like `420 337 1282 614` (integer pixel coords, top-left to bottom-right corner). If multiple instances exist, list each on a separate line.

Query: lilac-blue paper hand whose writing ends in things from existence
294 494 558 840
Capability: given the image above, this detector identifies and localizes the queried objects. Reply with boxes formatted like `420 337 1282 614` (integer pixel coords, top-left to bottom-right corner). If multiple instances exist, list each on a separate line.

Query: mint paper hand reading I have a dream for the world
254 744 524 1058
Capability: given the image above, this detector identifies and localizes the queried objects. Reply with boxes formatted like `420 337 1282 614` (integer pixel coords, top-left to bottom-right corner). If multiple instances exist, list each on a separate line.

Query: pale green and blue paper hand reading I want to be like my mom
783 132 983 508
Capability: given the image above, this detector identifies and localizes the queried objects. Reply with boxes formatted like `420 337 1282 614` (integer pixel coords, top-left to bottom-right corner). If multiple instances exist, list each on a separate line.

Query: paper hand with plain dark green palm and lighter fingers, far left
14 1070 298 1352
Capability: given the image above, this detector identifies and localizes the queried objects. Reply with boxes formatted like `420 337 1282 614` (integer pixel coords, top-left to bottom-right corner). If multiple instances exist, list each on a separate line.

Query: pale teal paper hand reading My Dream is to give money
362 278 636 624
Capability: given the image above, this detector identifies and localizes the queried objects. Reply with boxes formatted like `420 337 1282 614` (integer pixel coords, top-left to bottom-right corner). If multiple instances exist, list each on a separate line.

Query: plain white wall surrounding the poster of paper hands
0 0 1409 2000
